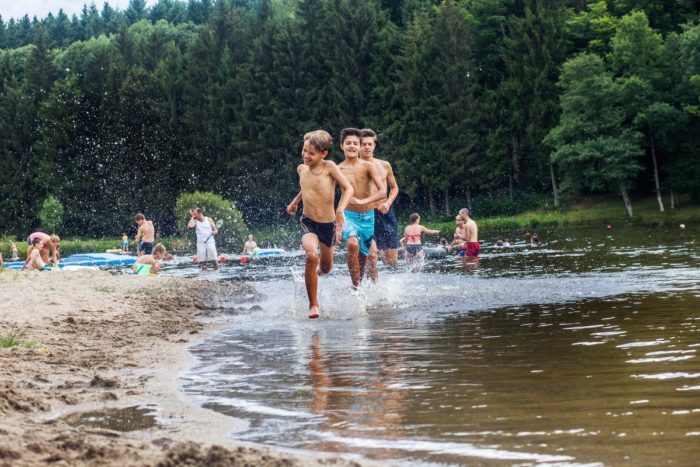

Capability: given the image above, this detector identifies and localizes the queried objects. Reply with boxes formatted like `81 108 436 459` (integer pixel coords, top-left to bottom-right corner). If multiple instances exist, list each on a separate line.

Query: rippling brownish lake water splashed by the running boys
176 228 700 465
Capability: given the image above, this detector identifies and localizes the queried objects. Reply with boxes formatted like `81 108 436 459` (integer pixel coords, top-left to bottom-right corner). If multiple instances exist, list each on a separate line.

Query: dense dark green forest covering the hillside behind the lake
0 0 700 237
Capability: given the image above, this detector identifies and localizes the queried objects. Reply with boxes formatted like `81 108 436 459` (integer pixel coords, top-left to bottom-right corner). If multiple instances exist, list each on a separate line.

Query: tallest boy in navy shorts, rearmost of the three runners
360 128 399 280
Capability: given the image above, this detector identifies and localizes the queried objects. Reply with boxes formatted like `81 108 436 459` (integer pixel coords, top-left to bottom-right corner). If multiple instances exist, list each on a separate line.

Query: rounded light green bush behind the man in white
175 191 248 248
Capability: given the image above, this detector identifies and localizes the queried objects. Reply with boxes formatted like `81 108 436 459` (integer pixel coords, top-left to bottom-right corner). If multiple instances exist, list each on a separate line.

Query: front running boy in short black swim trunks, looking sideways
287 130 354 318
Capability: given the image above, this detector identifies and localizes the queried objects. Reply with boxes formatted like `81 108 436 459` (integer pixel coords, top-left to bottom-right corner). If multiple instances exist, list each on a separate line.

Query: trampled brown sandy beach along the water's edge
0 270 357 466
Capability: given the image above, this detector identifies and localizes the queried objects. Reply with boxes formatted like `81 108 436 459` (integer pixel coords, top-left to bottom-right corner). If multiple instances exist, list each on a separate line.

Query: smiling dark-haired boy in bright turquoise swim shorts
338 128 386 288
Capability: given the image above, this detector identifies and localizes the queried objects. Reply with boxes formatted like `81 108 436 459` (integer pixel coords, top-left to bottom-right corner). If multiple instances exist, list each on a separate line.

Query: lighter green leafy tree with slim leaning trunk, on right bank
545 54 644 218
